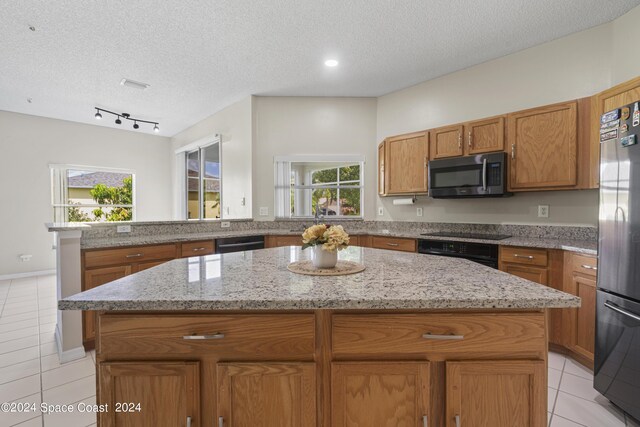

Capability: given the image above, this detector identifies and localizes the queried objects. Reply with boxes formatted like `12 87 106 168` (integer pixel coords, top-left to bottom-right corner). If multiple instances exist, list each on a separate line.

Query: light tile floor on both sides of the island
0 276 640 427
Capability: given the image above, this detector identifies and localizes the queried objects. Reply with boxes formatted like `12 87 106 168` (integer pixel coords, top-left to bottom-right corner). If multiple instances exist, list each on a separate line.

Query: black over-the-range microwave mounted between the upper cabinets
429 153 511 199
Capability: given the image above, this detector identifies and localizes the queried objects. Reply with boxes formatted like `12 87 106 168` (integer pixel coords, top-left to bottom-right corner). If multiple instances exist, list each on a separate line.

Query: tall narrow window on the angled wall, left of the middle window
185 140 222 219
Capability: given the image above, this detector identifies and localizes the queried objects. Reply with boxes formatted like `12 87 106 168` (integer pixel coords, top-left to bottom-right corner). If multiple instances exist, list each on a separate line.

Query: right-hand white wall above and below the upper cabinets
377 24 612 224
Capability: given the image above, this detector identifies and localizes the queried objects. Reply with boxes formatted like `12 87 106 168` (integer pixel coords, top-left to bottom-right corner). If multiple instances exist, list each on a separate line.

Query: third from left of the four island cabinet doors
331 362 430 427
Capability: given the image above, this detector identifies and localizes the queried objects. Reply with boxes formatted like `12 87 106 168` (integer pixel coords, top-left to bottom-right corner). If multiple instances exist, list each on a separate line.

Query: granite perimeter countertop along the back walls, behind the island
82 228 598 255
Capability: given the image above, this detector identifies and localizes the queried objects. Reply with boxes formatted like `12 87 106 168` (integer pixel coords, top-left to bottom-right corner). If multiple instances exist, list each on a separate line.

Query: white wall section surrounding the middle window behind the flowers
253 97 377 220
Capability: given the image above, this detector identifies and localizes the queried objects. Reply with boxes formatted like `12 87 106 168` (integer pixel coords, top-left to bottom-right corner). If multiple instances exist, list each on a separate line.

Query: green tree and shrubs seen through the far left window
67 176 133 222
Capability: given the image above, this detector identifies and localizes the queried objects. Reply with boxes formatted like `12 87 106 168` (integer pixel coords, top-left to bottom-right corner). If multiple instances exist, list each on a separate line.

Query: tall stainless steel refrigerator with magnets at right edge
594 102 640 419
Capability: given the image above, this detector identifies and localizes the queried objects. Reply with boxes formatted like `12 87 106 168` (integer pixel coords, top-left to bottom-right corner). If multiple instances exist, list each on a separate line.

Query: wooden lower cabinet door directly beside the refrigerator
565 273 596 362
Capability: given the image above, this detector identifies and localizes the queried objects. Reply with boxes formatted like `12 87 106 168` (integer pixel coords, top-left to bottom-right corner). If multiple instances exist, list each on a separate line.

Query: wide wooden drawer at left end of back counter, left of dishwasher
84 243 177 268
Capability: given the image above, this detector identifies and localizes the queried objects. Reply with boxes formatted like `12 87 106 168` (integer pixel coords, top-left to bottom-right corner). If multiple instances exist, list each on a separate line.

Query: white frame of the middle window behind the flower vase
274 155 366 220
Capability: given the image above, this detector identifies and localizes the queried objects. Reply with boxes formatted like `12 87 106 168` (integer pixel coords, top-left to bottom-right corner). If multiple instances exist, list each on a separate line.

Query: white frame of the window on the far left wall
49 163 138 224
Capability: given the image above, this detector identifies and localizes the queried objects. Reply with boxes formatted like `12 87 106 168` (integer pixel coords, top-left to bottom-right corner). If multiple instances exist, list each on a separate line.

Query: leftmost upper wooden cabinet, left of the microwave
378 132 429 196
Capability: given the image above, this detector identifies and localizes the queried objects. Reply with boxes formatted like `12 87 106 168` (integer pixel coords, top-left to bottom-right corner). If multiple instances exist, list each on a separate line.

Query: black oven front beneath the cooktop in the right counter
418 239 498 268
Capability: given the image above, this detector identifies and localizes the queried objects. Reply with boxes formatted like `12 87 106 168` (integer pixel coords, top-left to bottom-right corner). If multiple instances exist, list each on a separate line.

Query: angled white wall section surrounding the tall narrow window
171 97 253 219
